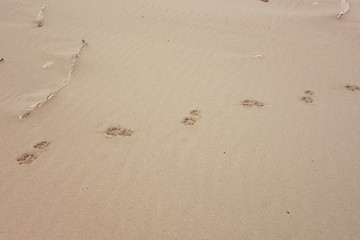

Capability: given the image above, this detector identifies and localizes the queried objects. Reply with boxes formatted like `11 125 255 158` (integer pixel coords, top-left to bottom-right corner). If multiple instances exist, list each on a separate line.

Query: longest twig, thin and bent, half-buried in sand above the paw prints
19 39 87 118
